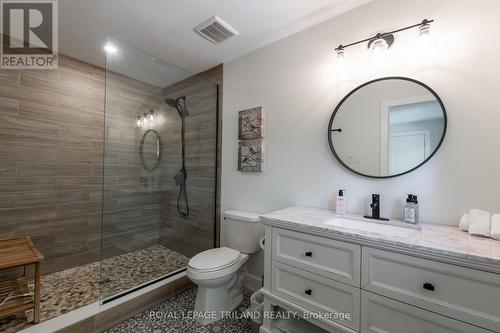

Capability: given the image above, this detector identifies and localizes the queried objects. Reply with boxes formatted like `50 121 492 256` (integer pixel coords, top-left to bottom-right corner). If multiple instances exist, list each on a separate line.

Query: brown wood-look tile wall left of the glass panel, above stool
0 56 104 272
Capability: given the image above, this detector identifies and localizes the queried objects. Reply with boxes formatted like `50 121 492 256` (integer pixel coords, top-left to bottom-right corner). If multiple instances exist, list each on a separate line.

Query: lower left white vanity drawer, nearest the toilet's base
271 261 360 331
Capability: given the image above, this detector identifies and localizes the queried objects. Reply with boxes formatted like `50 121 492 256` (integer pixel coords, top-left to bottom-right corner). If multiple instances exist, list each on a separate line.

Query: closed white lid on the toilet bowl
189 247 240 271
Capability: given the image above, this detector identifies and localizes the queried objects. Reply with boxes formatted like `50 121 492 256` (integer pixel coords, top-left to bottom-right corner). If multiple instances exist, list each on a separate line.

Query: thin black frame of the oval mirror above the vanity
327 76 448 179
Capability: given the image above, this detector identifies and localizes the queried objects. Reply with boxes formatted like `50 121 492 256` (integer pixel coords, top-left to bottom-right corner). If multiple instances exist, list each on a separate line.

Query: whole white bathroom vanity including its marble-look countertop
260 207 500 333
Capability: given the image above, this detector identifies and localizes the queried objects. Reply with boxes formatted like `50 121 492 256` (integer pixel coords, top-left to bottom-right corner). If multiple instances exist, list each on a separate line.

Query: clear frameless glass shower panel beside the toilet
101 39 218 301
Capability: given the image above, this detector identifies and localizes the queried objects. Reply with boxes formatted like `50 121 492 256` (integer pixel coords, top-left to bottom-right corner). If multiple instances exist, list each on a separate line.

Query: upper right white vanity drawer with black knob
361 247 500 332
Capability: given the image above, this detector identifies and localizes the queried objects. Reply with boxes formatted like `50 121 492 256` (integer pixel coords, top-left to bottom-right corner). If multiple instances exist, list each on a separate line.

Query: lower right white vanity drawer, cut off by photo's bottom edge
361 291 491 333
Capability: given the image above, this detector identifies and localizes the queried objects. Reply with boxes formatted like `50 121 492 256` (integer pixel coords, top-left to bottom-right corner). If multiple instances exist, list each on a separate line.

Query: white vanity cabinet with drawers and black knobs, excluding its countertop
260 222 500 333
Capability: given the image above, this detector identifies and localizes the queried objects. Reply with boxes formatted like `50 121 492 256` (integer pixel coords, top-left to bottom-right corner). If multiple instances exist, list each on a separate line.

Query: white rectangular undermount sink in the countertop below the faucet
325 217 420 238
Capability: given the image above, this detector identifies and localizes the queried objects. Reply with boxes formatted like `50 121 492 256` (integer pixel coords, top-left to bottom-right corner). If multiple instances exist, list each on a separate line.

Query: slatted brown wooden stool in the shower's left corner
0 236 43 324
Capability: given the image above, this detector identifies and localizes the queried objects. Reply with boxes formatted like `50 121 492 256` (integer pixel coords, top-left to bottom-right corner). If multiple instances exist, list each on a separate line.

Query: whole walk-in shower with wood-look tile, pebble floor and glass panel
0 39 218 333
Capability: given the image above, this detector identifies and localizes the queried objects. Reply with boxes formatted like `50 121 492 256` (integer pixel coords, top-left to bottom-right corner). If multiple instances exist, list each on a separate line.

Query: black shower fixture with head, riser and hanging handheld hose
165 96 189 217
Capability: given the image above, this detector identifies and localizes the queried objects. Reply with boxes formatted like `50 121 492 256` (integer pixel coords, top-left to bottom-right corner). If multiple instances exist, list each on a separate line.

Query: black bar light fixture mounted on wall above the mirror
335 19 434 59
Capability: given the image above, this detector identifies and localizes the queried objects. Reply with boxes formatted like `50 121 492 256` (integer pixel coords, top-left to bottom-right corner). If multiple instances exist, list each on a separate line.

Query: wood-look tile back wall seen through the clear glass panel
102 72 166 256
